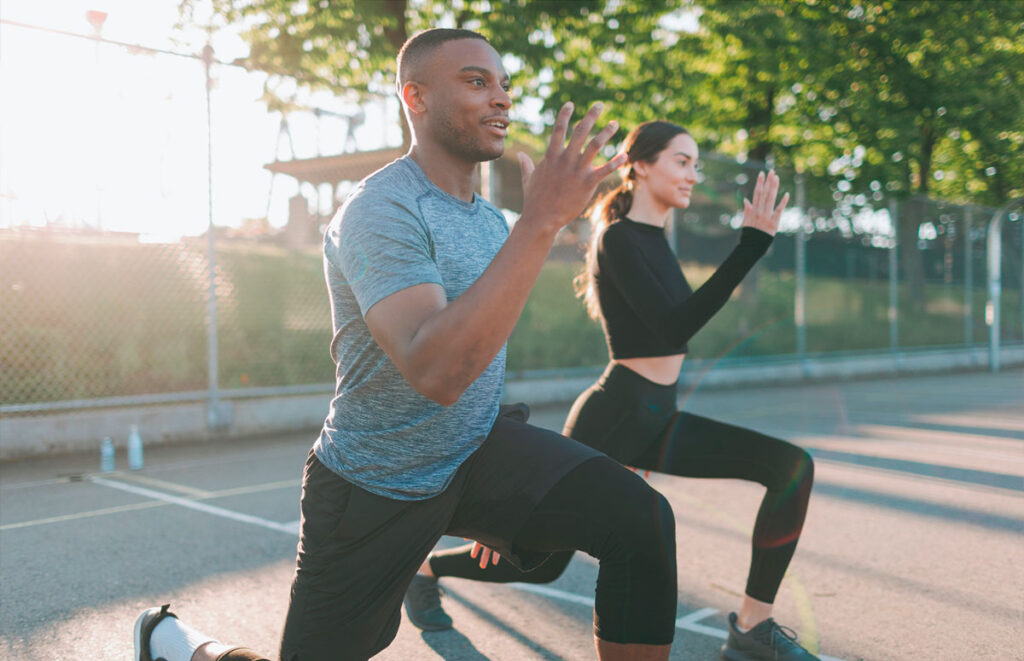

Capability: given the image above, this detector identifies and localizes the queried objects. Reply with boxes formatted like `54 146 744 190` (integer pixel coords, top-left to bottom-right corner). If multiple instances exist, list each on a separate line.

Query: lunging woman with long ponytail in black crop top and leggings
406 122 816 661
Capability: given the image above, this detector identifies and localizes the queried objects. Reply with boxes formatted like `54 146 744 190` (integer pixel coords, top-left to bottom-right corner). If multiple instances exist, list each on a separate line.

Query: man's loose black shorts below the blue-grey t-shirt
281 409 603 661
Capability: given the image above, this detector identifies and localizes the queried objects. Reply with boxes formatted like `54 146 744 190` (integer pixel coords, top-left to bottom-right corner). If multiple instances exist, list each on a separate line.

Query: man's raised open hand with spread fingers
519 103 626 237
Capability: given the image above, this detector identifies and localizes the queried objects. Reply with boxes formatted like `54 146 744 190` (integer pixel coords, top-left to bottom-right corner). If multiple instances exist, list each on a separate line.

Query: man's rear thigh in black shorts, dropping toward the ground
281 454 460 661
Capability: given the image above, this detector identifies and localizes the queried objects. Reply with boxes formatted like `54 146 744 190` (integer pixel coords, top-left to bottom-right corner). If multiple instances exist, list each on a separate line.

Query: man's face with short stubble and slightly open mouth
424 39 512 163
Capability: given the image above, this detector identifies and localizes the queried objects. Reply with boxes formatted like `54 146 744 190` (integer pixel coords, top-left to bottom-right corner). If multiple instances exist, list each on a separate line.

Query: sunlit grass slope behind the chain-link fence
0 238 1021 404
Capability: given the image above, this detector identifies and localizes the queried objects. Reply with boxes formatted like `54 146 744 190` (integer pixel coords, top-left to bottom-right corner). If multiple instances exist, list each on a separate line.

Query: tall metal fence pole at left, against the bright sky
203 44 225 429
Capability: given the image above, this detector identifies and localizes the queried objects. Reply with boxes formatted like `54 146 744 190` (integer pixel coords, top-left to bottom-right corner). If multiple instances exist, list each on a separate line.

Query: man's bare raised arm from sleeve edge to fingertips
366 103 625 406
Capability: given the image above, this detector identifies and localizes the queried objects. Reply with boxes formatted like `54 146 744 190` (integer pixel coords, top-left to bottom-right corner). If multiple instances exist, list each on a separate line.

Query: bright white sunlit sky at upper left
0 0 401 240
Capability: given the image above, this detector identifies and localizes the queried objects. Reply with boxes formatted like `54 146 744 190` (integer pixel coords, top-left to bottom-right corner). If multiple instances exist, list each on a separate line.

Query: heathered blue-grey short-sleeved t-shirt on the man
313 157 508 500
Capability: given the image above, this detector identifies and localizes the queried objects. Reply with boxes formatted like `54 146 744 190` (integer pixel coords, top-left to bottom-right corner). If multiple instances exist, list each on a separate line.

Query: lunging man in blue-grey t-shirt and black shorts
136 30 676 661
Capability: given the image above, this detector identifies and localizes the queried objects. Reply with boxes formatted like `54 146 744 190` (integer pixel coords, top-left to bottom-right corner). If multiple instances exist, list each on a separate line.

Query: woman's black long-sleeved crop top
591 218 772 359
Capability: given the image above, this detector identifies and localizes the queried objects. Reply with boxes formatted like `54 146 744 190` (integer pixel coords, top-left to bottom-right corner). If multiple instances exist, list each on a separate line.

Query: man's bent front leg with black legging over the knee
450 421 676 659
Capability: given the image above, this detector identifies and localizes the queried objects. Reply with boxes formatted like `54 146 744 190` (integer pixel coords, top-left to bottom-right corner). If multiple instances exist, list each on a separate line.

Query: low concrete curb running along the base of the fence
0 345 1024 462
